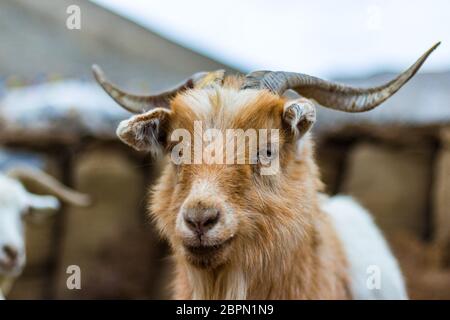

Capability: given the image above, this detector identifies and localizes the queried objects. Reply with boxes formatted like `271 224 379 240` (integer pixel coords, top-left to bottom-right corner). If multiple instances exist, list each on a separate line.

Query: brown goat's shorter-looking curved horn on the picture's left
92 64 214 113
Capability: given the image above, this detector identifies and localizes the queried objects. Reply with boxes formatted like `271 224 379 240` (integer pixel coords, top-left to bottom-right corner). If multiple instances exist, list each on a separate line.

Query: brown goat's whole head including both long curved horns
94 46 436 268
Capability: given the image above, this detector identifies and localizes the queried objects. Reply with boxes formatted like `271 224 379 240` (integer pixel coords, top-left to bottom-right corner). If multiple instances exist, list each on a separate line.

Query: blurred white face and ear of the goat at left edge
0 174 58 276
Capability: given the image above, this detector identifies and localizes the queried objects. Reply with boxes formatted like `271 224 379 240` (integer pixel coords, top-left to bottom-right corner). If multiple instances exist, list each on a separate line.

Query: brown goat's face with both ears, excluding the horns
117 84 315 268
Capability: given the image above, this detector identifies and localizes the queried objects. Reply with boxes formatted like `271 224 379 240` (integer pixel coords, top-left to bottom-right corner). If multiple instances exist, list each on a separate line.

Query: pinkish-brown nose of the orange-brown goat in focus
184 208 220 236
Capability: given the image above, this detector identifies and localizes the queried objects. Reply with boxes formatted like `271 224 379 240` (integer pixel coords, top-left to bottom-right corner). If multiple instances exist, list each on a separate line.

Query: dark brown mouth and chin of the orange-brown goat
184 237 233 268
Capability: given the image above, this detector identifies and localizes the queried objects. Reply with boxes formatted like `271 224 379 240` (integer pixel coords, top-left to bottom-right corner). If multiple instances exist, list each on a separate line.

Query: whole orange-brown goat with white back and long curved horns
93 44 438 299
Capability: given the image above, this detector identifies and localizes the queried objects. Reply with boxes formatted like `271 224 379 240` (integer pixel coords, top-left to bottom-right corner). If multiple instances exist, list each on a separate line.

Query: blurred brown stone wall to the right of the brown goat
317 126 450 299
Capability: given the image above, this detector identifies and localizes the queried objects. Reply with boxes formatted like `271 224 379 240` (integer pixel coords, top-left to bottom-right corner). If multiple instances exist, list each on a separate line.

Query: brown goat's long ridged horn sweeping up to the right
243 42 440 112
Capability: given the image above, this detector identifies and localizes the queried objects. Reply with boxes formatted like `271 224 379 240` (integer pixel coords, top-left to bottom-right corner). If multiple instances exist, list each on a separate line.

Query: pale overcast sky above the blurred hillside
93 0 450 77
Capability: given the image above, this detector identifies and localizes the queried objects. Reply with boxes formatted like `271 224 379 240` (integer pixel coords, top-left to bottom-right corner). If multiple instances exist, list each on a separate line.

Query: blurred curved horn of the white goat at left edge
6 167 91 207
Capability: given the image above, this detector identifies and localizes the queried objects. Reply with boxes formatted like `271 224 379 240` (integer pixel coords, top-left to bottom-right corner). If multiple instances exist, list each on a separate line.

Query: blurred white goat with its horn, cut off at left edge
0 167 90 299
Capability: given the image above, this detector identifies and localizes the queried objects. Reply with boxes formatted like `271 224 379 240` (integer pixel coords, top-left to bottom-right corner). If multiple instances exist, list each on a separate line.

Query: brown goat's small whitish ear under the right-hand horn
283 98 316 140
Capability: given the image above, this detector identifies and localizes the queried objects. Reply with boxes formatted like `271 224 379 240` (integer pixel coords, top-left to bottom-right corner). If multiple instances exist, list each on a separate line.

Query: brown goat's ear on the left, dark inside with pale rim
116 108 172 155
